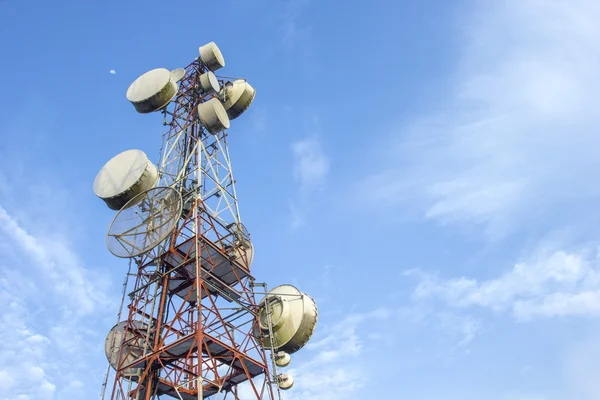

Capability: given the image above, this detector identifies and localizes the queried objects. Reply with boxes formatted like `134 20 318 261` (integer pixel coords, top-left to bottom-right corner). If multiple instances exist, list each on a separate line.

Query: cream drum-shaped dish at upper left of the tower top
127 68 179 114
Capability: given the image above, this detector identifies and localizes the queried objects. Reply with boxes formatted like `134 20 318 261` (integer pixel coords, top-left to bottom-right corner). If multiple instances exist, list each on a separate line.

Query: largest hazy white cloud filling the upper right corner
365 0 600 235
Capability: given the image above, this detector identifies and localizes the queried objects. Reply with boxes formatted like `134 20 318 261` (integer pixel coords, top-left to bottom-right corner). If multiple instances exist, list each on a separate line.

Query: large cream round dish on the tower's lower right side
254 285 317 354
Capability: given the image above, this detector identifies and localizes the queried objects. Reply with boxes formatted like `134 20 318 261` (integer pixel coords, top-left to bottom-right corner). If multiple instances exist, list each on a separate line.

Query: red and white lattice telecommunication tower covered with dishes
94 42 317 400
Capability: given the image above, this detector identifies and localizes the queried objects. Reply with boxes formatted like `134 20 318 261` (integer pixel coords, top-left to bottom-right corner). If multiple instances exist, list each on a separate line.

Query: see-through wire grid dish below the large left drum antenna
106 187 182 258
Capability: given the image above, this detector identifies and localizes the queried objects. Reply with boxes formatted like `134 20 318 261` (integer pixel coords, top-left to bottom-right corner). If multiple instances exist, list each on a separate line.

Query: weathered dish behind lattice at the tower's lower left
104 321 148 381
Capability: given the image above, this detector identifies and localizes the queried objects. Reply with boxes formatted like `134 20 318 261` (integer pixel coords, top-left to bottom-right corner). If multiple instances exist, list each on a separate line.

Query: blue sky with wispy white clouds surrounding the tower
0 0 600 400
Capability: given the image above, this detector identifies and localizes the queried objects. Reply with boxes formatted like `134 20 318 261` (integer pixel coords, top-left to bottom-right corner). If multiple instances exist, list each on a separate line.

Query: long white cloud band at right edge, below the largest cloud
413 250 600 320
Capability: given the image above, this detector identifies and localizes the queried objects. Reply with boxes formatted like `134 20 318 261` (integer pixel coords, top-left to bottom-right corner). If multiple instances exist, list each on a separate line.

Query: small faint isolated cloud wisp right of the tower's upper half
292 137 329 192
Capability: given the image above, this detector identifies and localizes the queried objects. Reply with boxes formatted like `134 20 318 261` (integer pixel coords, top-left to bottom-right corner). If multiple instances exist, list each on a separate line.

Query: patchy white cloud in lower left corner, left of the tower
0 199 116 400
